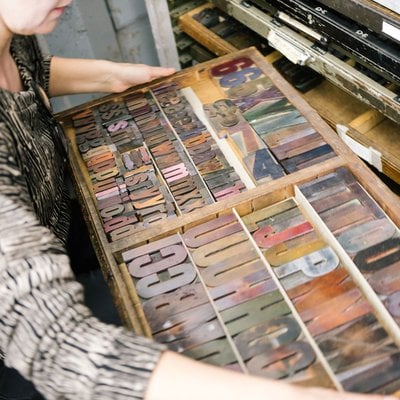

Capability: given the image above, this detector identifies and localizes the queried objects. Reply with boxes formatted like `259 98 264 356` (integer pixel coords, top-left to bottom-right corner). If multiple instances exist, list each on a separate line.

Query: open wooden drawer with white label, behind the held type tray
179 3 400 184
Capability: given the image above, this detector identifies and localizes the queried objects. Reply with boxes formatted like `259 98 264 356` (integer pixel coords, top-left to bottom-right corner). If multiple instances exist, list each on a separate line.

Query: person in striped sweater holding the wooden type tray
0 0 396 400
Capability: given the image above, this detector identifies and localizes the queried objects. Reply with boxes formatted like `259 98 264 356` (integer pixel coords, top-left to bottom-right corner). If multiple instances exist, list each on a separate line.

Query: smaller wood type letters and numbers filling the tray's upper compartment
73 53 335 241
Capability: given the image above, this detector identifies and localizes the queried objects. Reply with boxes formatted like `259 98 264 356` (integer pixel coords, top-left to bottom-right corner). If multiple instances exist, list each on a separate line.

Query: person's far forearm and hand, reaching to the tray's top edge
49 57 175 97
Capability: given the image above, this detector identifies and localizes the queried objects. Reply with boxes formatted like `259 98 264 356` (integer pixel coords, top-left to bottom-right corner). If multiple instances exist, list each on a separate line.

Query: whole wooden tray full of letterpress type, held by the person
59 49 400 392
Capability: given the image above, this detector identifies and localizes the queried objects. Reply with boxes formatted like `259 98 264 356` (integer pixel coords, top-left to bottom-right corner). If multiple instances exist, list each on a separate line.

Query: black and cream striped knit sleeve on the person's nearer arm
0 125 164 400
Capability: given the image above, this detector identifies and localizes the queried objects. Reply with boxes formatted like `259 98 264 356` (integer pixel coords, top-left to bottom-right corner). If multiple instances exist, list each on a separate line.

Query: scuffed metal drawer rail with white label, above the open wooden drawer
209 0 400 123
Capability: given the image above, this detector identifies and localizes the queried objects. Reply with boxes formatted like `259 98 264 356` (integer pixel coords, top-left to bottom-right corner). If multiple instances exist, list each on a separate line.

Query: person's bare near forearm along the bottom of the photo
145 351 396 400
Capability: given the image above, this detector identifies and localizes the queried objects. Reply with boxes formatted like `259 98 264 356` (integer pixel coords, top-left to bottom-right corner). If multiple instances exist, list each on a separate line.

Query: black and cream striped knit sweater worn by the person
0 36 164 400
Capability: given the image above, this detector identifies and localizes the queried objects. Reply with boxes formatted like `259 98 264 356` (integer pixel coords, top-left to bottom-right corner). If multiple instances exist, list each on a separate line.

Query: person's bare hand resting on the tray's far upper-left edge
109 63 175 93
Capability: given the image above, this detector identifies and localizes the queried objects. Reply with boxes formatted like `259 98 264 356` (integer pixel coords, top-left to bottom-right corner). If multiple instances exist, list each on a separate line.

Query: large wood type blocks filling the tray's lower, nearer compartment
122 168 400 393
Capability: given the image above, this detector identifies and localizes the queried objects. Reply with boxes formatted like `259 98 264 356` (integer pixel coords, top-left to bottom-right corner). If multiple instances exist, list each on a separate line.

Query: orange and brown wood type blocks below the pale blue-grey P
288 268 400 392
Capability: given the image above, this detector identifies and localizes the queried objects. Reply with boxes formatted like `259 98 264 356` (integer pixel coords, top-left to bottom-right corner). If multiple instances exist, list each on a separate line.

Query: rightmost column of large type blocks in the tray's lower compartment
301 169 400 323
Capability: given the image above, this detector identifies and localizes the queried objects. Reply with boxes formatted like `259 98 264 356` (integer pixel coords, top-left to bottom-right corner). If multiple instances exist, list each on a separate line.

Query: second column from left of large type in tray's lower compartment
184 214 329 381
